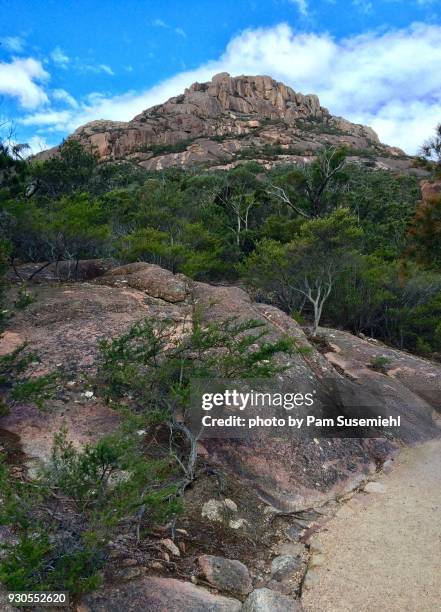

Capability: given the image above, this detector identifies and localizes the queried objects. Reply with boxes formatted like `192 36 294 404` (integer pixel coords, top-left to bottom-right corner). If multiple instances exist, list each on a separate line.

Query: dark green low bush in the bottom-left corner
0 456 102 593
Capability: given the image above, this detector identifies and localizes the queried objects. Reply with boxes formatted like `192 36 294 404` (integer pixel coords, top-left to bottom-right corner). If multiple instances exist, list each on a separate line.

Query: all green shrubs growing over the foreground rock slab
0 316 295 594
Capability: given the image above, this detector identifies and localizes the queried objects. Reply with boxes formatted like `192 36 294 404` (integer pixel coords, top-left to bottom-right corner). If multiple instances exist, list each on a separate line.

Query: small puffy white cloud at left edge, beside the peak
0 57 49 109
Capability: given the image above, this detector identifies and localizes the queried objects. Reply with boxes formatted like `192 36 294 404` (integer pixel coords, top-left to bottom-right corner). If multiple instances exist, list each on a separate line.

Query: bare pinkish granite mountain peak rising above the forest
45 72 403 170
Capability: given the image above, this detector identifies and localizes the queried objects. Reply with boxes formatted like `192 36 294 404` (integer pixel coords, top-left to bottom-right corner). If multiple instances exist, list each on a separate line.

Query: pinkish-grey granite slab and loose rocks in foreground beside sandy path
0 263 441 612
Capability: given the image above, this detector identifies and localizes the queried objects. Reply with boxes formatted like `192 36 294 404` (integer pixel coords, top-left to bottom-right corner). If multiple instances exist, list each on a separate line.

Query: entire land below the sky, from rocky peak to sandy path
0 61 441 612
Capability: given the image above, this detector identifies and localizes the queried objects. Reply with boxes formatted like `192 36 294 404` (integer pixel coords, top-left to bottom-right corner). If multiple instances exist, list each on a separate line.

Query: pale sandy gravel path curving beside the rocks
303 440 441 612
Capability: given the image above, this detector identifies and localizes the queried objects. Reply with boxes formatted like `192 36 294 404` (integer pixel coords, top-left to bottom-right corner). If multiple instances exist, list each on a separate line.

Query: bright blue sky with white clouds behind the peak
0 0 441 152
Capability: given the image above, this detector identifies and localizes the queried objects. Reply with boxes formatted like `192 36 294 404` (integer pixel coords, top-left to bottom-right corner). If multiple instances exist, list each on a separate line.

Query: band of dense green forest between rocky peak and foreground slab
0 139 441 355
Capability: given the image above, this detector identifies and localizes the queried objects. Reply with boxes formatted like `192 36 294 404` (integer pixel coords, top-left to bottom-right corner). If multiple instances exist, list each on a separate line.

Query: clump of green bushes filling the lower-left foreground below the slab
0 431 180 594
